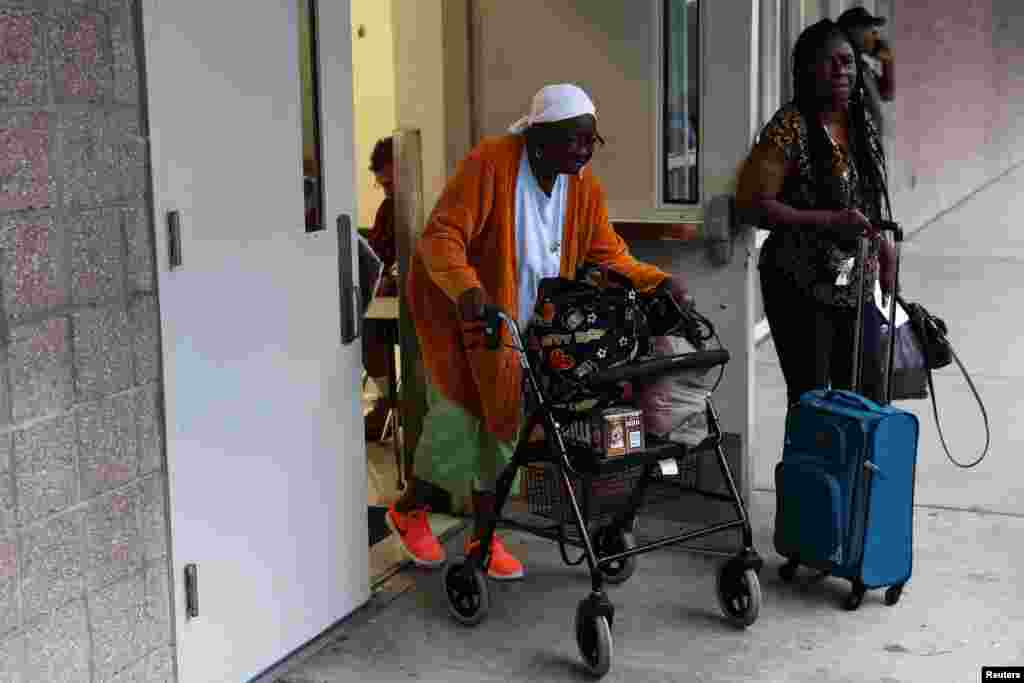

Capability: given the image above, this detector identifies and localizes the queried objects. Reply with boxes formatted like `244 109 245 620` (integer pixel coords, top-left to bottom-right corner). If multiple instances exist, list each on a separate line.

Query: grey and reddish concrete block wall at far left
0 0 173 683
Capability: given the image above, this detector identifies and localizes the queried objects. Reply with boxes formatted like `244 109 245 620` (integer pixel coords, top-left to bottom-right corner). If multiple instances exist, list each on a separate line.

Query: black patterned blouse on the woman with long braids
758 102 881 307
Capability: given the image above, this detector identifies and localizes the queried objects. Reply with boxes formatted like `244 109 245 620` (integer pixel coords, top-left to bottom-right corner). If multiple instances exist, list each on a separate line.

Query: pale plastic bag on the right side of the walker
637 337 710 446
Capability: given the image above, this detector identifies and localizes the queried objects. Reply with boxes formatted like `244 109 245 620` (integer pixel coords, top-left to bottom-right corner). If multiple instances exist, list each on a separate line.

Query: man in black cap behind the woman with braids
837 7 893 136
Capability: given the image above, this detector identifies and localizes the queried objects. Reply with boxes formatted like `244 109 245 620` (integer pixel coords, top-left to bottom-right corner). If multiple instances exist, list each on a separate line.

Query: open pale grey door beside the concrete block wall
142 0 370 683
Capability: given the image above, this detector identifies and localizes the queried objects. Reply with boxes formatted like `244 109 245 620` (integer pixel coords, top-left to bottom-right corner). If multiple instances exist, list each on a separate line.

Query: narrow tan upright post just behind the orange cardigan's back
393 129 427 481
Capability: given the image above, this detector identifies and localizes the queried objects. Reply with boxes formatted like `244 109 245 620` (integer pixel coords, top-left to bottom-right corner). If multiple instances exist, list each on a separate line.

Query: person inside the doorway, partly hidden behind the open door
362 137 398 441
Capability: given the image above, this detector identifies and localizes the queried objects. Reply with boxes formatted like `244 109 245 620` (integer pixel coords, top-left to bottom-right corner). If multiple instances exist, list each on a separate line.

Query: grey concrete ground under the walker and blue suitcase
279 493 1024 683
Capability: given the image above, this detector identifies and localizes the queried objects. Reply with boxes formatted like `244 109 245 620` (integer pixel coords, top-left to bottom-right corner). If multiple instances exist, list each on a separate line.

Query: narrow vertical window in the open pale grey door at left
298 0 324 232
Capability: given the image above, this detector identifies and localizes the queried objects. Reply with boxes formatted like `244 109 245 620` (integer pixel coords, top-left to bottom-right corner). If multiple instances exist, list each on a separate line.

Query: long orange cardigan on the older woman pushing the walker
407 135 668 441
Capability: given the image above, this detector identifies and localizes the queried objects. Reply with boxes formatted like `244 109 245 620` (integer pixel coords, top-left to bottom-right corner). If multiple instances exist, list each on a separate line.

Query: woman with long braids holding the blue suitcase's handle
736 19 895 405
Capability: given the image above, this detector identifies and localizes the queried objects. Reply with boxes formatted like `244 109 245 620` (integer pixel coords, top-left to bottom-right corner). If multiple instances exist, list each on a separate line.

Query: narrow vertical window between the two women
662 0 700 204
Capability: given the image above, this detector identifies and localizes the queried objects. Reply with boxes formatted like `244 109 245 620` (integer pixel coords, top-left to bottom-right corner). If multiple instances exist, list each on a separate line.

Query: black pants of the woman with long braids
761 268 882 405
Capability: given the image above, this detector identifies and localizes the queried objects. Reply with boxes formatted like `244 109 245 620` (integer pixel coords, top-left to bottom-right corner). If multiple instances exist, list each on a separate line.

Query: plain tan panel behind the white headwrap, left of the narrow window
473 0 659 220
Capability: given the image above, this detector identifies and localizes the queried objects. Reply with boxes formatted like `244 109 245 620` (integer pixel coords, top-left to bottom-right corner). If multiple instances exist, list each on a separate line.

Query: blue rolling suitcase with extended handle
773 224 920 609
